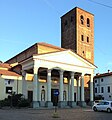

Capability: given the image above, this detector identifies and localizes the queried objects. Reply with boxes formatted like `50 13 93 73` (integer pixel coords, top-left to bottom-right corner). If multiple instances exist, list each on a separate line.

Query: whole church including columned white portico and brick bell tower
6 7 96 108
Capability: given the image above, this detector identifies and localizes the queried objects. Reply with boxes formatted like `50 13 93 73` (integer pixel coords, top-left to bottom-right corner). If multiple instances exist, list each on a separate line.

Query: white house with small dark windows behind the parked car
94 71 112 100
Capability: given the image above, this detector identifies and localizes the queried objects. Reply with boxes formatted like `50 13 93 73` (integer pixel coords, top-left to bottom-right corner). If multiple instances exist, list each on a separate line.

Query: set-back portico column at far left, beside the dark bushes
22 70 27 98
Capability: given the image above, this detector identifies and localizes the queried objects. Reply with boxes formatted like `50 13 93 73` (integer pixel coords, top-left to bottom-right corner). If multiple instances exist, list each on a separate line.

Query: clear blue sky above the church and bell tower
0 0 112 73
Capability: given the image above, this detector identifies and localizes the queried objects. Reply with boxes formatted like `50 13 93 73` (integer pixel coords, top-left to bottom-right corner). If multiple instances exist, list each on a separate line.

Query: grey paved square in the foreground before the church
0 108 112 120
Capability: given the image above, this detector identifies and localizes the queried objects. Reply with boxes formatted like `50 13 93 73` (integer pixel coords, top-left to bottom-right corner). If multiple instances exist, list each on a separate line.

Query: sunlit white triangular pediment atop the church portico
35 50 96 68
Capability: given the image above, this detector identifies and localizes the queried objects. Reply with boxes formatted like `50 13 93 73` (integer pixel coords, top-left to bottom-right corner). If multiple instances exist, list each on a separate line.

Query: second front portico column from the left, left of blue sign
46 69 53 107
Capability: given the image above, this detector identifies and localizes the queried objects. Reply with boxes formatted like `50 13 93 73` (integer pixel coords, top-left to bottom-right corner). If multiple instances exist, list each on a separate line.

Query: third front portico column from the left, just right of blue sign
59 70 65 108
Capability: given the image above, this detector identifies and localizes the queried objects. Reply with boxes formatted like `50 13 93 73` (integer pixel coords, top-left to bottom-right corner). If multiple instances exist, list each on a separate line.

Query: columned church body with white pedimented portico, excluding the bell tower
6 43 96 108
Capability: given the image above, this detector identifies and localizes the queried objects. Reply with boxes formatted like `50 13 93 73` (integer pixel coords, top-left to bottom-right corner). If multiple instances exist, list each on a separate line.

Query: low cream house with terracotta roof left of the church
0 63 22 100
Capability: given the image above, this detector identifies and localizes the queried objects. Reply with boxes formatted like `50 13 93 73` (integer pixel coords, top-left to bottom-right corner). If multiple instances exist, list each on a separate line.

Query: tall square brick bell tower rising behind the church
61 7 94 64
